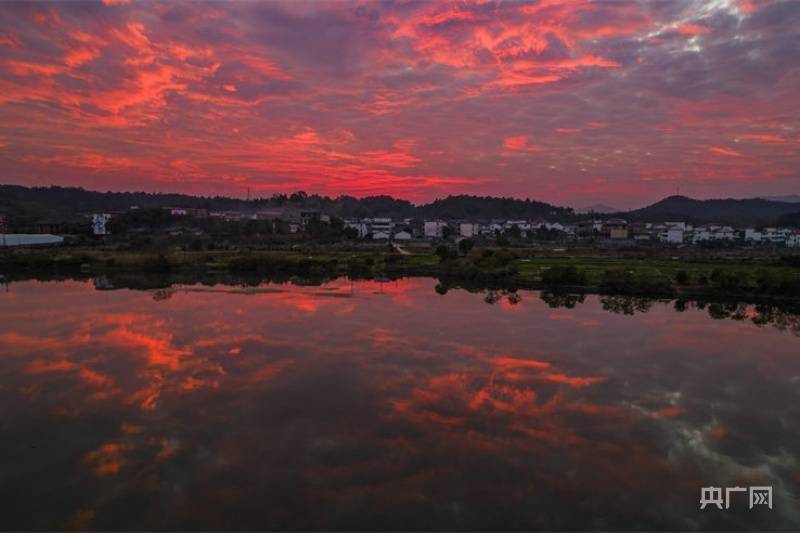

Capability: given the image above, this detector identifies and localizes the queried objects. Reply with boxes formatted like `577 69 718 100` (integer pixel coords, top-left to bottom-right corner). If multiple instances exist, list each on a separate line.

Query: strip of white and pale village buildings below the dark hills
0 207 800 248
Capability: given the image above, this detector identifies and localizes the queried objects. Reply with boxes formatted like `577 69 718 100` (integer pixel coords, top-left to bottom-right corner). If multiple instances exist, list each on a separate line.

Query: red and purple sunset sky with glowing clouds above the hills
0 0 800 208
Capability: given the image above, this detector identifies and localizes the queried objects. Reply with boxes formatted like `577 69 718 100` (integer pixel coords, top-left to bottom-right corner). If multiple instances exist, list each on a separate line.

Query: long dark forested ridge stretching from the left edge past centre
0 185 572 220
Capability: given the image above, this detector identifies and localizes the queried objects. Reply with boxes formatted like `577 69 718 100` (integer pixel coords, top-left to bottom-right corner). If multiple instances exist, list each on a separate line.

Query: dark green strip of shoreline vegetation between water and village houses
0 241 800 304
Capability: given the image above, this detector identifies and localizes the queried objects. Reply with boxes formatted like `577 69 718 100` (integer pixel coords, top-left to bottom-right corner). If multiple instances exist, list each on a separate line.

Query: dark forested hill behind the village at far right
621 196 800 226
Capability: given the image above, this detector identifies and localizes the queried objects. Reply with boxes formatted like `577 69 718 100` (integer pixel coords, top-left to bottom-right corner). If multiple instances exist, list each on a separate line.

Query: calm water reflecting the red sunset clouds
0 278 800 530
